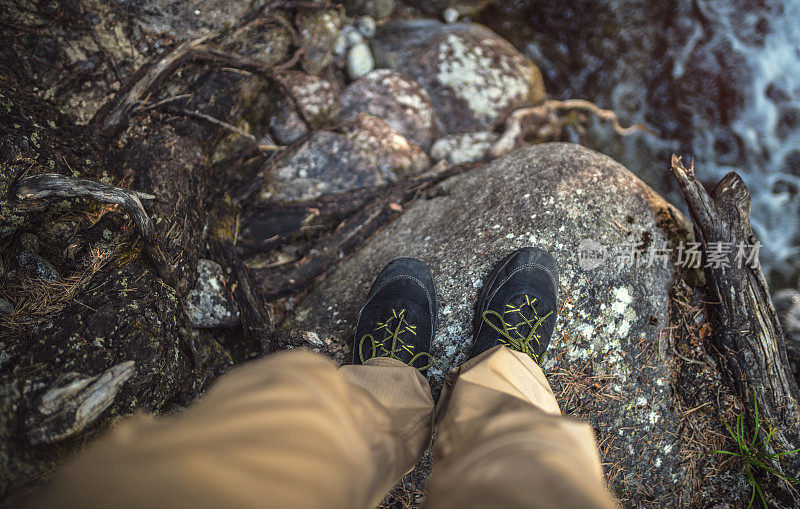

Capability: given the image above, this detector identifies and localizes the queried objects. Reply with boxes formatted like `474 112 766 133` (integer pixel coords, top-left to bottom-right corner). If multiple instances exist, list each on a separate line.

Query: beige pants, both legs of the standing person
35 347 614 509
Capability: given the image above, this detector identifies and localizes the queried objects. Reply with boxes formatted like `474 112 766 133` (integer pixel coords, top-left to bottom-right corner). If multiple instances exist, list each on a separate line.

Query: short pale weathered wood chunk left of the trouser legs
25 361 135 445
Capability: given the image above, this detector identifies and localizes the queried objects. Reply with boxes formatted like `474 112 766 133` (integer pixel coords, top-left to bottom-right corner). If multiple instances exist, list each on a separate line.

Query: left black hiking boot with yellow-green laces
353 258 436 374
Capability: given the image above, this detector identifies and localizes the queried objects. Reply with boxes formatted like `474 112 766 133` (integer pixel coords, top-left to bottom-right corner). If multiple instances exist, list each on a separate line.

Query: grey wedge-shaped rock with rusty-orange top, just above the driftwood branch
261 115 430 201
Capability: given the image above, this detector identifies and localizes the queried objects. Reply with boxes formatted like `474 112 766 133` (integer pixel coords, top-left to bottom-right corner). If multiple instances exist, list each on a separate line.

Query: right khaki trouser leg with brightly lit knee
427 347 615 509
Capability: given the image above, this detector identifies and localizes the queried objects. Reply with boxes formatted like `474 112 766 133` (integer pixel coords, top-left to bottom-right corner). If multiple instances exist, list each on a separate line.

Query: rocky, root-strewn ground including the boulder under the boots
0 0 776 507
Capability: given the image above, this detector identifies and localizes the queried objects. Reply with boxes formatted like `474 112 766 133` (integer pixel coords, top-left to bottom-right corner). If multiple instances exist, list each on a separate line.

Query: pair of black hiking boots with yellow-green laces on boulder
353 247 558 373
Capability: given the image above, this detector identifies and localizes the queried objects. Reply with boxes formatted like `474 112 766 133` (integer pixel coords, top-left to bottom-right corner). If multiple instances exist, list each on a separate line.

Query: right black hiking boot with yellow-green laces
469 247 558 363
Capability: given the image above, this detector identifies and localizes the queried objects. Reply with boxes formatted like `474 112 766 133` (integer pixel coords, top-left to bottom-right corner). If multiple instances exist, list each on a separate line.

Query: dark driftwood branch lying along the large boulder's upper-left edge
253 162 475 300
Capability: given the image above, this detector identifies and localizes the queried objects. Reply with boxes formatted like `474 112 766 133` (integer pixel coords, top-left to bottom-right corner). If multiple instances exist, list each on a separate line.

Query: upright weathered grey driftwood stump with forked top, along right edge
671 156 800 507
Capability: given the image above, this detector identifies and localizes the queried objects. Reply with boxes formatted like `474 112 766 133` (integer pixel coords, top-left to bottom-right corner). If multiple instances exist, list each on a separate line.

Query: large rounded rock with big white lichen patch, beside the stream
371 20 545 134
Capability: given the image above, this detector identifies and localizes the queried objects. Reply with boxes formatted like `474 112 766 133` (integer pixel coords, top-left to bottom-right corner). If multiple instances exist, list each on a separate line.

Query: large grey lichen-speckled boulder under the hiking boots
291 143 700 503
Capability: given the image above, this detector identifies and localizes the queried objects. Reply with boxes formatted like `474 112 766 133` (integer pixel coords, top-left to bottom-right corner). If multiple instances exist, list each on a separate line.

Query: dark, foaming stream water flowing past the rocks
479 0 800 334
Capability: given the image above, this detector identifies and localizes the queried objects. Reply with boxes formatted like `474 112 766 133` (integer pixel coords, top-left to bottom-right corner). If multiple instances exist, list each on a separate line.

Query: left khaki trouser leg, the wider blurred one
36 352 433 509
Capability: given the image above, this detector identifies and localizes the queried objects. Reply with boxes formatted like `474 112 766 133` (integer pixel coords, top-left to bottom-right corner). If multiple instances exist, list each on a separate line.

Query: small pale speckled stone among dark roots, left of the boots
184 260 239 329
